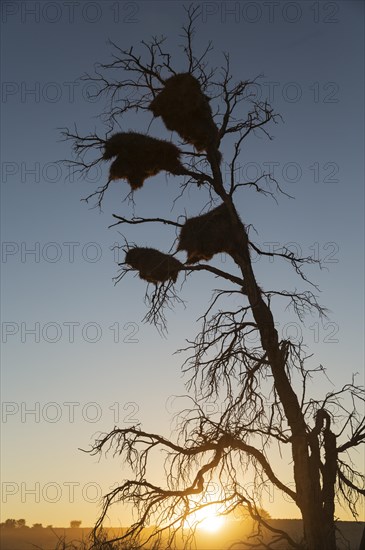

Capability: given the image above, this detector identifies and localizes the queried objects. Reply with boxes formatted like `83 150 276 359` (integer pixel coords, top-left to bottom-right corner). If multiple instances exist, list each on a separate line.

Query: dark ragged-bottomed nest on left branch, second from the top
103 132 186 189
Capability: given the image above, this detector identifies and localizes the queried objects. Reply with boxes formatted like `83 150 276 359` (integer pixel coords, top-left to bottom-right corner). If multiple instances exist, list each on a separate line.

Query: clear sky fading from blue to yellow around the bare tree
1 0 364 526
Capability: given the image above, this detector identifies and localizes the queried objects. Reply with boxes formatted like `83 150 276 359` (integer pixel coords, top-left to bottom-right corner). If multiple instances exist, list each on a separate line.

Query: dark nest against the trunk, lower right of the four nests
177 203 235 264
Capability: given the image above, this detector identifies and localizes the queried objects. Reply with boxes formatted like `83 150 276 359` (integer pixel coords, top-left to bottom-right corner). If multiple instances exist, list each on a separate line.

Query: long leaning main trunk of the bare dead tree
208 148 336 550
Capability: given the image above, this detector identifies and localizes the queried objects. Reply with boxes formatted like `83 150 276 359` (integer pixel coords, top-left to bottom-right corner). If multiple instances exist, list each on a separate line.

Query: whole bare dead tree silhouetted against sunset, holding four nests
64 7 365 550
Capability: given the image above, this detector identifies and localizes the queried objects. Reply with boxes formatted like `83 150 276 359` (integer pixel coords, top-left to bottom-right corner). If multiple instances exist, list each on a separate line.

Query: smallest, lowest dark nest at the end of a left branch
125 247 184 284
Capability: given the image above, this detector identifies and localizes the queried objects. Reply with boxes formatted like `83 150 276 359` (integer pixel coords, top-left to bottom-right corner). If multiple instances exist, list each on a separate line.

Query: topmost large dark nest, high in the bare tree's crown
149 73 218 151
